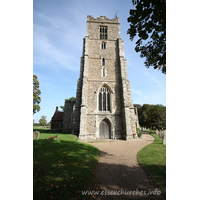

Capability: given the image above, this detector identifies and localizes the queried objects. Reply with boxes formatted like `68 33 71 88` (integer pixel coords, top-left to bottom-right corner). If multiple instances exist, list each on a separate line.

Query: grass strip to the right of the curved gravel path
137 134 166 195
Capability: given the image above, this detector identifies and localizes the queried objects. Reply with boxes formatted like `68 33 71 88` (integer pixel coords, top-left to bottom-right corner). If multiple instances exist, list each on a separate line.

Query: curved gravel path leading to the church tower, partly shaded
92 133 165 200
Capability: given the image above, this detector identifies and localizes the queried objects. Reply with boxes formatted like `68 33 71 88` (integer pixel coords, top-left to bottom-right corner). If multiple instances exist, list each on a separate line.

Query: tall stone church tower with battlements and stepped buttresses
63 16 139 140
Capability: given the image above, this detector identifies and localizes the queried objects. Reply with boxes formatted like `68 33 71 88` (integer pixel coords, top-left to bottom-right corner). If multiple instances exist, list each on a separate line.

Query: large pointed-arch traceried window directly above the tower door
98 85 110 111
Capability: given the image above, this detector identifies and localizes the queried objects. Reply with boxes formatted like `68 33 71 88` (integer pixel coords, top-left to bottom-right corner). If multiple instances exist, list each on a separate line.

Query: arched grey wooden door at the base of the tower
99 119 111 139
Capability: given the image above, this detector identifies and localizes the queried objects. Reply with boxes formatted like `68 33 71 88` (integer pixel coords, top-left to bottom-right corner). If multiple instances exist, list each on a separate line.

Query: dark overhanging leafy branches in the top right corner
127 0 166 74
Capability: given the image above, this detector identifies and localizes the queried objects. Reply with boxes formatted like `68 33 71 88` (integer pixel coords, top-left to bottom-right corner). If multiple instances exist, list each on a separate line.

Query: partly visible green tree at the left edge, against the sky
33 74 41 114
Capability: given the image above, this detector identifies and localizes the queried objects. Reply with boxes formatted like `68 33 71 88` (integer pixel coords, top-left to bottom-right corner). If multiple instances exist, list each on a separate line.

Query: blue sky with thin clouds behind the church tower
33 0 166 122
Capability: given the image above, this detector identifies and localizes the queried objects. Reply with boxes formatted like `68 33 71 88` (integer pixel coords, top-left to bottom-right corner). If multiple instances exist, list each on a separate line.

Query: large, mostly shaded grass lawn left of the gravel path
33 129 99 199
